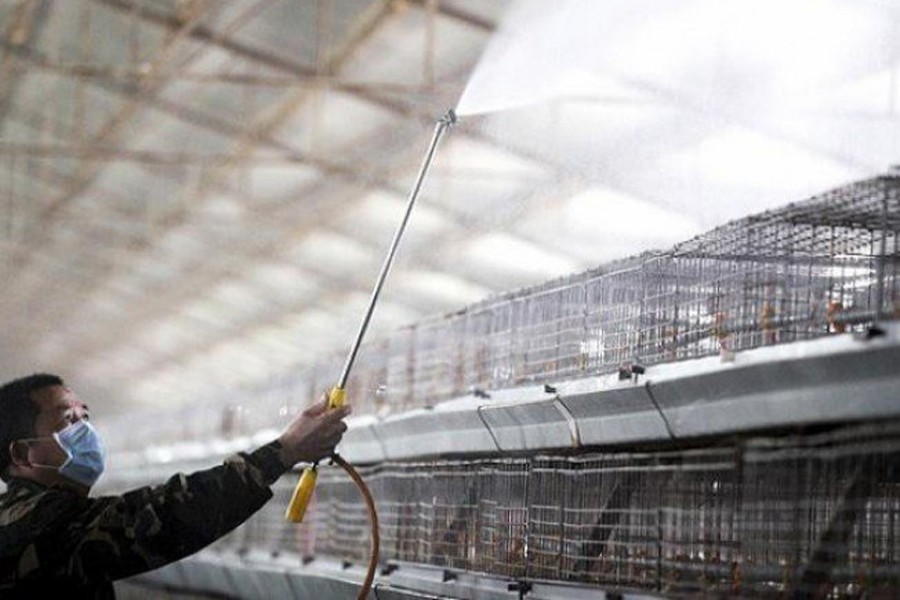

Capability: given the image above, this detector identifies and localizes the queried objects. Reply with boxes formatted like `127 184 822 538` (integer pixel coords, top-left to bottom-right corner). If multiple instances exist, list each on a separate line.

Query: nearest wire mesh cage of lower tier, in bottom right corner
737 424 900 597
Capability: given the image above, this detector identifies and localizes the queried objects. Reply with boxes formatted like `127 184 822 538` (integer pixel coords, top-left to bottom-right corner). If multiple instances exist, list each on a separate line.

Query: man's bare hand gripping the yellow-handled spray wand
278 395 350 467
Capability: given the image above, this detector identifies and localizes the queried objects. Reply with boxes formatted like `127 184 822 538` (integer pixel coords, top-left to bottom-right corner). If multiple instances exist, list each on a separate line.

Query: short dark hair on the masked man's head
0 373 63 481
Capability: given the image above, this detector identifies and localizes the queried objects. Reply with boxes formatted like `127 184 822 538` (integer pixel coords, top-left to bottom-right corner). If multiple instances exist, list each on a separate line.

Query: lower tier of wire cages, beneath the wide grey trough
214 423 900 598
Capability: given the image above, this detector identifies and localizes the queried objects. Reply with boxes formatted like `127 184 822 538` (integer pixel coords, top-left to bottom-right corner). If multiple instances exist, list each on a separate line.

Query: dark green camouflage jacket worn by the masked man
0 441 286 600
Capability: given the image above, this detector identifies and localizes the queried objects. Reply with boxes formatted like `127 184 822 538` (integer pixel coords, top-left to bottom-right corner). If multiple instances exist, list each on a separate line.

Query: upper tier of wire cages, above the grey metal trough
102 177 900 448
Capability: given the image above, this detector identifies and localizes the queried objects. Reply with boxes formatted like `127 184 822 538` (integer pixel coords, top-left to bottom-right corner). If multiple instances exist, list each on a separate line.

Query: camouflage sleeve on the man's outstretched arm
60 441 286 579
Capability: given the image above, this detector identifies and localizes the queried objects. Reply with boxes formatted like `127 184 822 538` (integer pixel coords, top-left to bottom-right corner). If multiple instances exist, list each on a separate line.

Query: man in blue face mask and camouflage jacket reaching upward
0 374 350 600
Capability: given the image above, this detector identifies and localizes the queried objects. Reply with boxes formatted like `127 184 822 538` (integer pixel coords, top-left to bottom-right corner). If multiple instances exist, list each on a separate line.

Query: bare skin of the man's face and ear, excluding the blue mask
12 385 88 491
